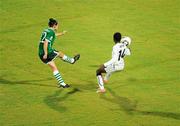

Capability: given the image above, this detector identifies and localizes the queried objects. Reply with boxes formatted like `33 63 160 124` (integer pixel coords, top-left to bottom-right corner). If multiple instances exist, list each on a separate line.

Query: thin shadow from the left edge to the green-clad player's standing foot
0 78 56 87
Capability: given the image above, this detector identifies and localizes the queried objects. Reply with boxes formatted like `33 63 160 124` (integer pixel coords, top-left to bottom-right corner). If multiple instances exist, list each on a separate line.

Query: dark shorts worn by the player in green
39 50 58 64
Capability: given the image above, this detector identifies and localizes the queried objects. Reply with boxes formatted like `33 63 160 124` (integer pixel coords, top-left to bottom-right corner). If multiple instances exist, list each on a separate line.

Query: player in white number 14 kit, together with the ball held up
96 32 131 93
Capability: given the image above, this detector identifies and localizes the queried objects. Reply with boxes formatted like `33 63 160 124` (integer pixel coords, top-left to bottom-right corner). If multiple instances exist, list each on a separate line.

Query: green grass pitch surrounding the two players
0 0 180 126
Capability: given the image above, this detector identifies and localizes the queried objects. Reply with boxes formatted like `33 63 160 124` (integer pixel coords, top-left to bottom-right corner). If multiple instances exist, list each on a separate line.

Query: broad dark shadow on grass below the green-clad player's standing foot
44 88 79 112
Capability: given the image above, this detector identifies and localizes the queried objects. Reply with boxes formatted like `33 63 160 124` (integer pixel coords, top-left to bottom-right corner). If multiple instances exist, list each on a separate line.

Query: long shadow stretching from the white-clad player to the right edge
100 88 180 120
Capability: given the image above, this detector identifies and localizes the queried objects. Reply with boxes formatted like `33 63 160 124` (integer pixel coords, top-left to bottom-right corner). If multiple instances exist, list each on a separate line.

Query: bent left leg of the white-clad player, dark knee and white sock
96 65 106 93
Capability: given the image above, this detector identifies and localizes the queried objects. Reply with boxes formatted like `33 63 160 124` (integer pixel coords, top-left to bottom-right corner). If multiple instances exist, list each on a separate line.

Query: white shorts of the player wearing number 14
105 63 124 73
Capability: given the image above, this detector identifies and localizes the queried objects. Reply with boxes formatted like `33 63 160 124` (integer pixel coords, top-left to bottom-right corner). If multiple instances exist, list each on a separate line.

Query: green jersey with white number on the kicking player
39 28 56 56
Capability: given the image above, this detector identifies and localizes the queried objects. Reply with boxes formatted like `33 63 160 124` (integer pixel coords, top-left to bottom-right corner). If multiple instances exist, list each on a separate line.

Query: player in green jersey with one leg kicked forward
39 18 80 88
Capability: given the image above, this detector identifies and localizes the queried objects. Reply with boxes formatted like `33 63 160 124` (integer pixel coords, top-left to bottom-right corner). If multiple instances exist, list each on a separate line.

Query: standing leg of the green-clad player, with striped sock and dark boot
48 61 69 88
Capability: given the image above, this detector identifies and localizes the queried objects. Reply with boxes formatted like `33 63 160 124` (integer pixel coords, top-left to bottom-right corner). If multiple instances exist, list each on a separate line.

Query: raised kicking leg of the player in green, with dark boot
58 52 80 64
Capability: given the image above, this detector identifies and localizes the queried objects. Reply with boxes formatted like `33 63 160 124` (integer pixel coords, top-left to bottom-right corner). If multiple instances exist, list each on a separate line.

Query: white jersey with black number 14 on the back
104 43 131 67
